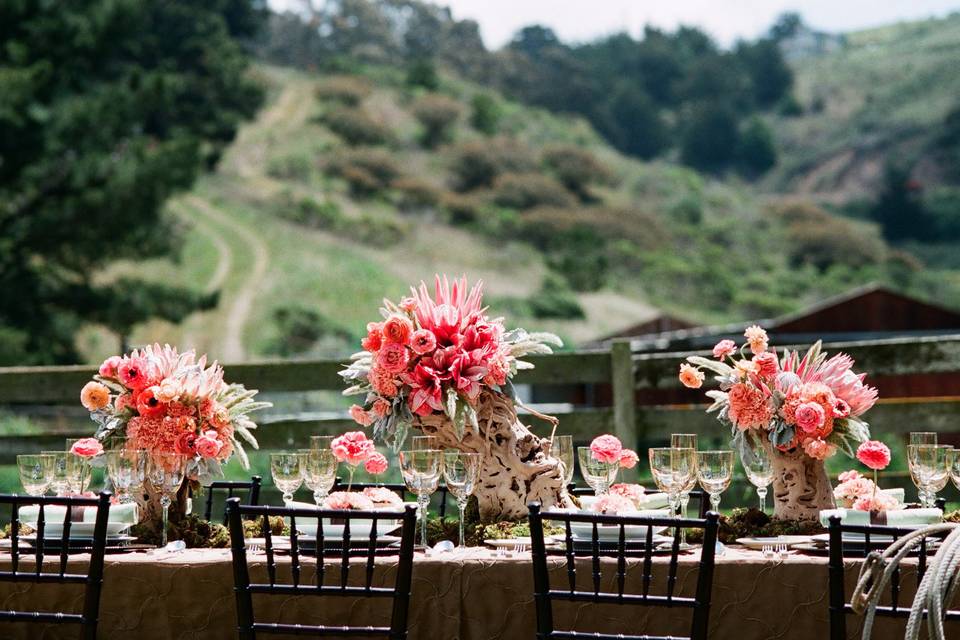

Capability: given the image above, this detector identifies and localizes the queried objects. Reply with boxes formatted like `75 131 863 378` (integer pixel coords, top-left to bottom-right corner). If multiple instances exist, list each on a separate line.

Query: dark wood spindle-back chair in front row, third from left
529 503 719 640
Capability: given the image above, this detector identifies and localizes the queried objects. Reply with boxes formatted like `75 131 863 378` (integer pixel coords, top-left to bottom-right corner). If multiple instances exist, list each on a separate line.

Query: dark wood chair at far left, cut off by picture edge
0 492 110 640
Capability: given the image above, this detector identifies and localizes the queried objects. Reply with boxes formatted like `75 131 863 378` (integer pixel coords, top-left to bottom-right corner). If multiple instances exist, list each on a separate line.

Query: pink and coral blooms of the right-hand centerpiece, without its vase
680 325 876 462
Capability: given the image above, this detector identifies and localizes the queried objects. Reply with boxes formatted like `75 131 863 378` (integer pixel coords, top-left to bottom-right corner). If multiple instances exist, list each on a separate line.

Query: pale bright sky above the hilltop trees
438 0 960 49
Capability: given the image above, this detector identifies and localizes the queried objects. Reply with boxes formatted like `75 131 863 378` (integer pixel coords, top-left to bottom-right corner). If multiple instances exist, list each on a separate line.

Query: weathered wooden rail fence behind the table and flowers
0 334 960 464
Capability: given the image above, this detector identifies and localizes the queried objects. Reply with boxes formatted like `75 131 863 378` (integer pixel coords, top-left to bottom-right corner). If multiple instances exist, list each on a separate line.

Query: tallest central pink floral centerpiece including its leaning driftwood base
341 276 572 522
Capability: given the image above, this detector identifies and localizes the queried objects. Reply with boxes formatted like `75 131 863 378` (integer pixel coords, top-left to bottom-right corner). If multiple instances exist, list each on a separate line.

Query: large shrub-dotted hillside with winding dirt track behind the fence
75 62 944 361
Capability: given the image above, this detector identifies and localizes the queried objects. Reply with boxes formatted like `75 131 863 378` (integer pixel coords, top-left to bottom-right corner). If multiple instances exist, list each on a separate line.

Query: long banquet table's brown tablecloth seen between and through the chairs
0 546 928 640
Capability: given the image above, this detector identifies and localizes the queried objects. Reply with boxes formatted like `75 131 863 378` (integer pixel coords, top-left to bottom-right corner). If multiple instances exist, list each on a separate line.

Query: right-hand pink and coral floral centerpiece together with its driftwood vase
680 326 877 520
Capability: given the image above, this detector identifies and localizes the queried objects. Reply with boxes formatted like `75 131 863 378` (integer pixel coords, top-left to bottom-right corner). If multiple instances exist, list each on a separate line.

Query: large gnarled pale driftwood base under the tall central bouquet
414 391 573 523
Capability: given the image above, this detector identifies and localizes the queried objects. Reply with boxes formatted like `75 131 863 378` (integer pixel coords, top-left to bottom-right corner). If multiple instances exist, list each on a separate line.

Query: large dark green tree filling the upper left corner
0 0 261 364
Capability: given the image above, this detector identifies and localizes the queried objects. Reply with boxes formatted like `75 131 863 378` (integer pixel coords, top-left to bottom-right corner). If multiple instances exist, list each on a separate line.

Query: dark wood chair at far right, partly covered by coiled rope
828 516 960 640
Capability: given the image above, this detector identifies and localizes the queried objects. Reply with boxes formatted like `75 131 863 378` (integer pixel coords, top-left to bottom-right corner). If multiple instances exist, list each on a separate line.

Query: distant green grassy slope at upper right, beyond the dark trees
763 14 960 200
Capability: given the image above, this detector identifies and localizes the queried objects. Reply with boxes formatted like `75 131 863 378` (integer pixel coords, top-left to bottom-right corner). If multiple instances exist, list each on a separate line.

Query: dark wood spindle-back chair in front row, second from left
227 498 417 640
